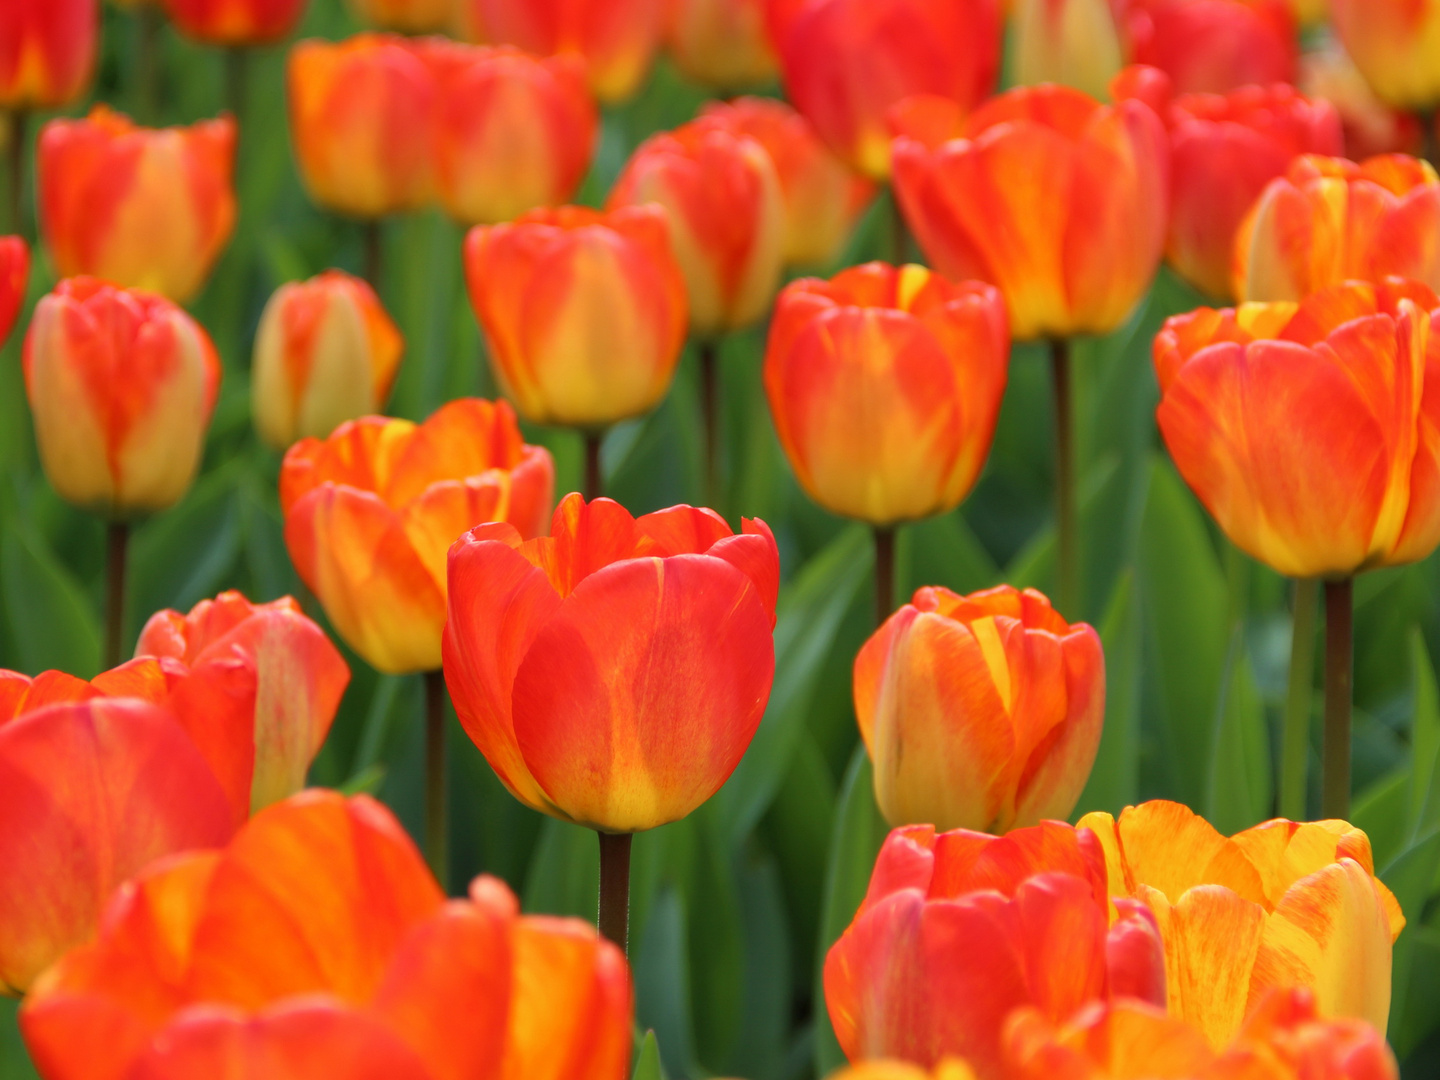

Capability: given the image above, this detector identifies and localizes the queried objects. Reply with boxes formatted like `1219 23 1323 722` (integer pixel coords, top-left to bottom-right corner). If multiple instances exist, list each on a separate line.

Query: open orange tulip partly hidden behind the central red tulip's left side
279 397 554 674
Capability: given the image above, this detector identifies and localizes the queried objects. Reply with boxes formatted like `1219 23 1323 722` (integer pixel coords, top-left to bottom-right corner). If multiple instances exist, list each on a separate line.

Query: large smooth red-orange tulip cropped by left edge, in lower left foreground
0 696 232 994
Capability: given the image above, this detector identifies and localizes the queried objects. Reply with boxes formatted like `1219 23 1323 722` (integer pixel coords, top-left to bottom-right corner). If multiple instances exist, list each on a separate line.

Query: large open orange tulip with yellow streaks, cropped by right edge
1155 279 1440 577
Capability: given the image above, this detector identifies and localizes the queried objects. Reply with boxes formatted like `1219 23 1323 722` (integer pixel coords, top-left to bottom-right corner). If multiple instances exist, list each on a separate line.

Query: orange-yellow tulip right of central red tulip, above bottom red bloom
854 585 1104 832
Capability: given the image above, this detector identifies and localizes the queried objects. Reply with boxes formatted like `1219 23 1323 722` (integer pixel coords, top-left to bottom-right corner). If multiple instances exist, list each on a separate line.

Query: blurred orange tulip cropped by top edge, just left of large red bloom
665 0 779 91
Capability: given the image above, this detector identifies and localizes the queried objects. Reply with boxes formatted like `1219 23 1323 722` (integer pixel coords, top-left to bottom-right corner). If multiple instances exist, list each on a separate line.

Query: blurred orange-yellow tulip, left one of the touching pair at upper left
287 33 436 217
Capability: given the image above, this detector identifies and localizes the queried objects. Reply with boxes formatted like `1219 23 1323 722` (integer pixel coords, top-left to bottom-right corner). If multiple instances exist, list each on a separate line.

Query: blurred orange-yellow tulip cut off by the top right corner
1331 0 1440 111
